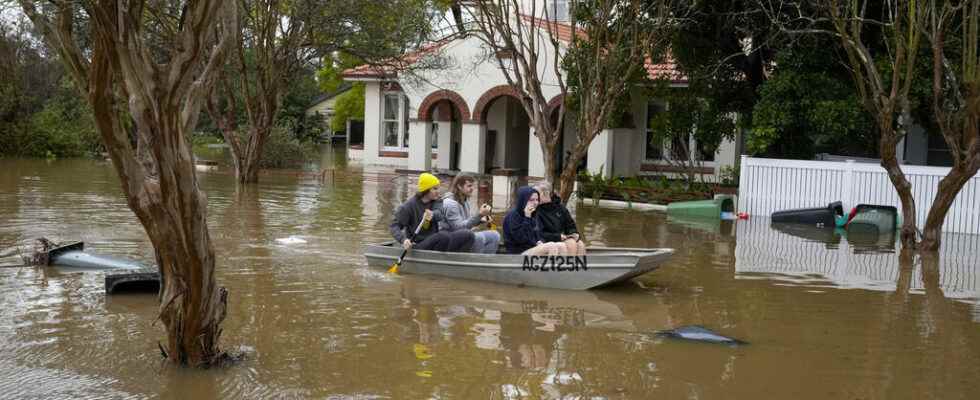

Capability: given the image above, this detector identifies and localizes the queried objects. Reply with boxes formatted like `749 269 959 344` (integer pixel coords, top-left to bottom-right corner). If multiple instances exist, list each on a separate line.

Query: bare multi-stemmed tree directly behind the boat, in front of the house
461 0 673 201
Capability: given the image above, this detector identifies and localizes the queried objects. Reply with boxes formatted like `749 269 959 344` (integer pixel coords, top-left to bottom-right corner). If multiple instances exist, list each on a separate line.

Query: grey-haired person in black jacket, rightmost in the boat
534 181 585 255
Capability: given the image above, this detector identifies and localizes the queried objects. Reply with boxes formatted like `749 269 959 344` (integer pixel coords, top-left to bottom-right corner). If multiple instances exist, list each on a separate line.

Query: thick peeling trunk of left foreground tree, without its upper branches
90 88 227 366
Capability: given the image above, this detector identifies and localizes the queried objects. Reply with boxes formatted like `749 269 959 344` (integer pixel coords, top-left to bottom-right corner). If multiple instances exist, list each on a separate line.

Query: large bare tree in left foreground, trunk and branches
19 0 238 366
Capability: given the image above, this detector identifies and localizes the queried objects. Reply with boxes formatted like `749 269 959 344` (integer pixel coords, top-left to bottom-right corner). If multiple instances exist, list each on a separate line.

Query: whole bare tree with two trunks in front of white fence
777 0 980 251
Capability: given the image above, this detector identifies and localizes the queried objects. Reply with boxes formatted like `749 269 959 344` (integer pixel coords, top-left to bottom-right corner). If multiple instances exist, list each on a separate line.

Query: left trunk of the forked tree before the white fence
878 119 916 249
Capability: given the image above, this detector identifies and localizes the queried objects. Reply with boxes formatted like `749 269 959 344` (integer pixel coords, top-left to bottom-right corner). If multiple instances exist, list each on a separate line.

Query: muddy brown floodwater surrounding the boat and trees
0 148 980 399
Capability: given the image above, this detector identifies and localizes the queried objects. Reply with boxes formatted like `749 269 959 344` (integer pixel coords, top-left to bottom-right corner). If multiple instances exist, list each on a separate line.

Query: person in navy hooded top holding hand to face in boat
504 186 567 256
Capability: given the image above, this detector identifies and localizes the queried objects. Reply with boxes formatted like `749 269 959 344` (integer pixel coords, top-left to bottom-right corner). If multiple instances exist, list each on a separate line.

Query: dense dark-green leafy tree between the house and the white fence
648 0 781 182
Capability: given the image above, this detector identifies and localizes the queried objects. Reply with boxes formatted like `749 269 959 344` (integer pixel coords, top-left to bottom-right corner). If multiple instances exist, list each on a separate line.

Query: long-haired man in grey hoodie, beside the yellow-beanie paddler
439 173 500 254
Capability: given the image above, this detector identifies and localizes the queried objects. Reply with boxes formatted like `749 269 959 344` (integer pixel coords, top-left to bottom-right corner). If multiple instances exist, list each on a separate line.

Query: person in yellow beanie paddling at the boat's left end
390 172 473 252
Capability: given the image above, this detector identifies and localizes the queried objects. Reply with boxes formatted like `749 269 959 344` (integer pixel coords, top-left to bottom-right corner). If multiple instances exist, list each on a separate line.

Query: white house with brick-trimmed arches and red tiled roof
342 0 740 180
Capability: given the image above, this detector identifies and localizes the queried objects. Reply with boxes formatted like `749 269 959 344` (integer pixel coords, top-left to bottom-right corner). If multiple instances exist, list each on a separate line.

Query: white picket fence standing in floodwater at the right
738 156 980 234
